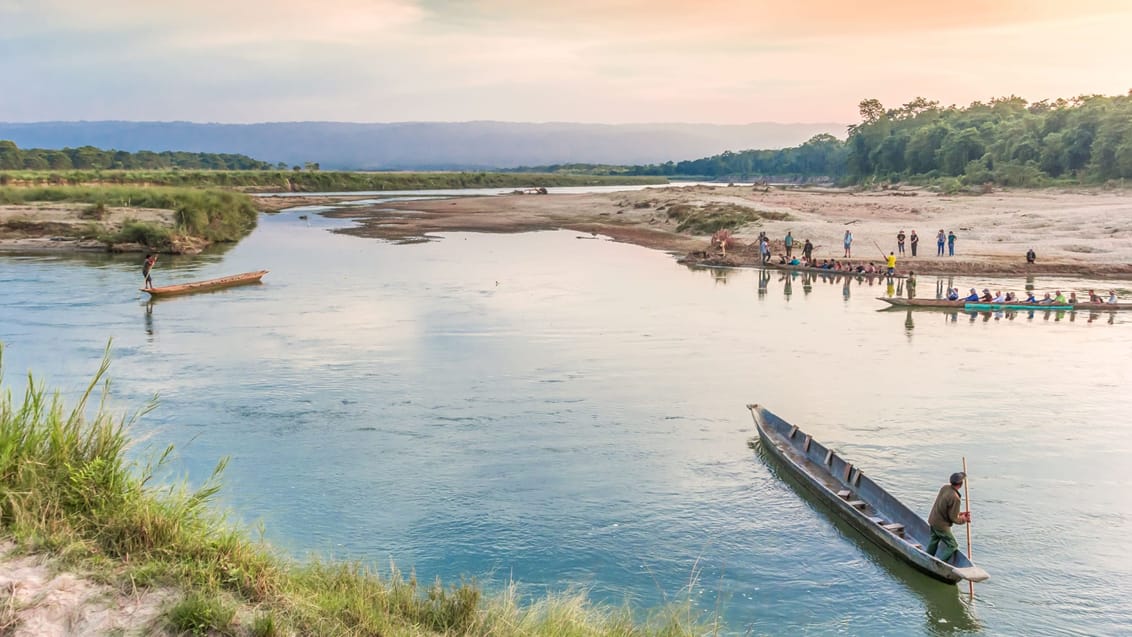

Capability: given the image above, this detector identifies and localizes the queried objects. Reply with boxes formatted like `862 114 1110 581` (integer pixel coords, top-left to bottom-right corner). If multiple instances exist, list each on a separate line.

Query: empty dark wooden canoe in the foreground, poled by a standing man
747 405 991 584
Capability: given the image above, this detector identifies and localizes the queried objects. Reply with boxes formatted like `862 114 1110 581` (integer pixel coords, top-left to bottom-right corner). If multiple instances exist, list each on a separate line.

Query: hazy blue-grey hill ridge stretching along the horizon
0 121 846 170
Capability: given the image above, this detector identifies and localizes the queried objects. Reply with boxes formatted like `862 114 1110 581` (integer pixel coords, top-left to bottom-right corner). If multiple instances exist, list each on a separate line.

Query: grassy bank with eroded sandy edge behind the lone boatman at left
0 186 257 252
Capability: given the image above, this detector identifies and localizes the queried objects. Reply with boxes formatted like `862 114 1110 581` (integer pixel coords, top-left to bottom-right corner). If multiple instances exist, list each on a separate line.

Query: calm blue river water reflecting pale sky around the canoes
0 192 1132 635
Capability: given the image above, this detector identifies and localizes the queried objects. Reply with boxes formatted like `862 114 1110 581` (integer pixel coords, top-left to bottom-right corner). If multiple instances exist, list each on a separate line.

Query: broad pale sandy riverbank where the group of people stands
337 186 1132 278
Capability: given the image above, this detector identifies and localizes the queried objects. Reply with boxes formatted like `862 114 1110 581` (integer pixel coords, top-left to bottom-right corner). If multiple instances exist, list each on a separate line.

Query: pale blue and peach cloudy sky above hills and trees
0 0 1132 123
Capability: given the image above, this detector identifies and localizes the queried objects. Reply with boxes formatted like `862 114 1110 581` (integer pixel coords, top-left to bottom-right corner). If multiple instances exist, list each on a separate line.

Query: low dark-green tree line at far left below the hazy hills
0 139 272 171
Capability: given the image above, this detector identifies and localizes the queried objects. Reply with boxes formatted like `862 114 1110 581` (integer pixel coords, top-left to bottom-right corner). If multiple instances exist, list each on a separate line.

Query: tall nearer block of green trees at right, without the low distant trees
846 92 1132 186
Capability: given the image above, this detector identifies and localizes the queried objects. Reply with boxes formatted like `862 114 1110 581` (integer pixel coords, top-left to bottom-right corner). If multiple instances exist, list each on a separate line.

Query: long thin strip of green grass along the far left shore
0 170 668 192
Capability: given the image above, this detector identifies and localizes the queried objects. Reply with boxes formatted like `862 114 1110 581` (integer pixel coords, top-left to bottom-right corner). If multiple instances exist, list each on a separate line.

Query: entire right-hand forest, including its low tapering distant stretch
626 92 1132 186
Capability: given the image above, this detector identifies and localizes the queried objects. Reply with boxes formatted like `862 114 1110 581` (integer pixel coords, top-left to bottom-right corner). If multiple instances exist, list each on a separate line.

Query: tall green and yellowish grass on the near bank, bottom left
0 346 719 637
